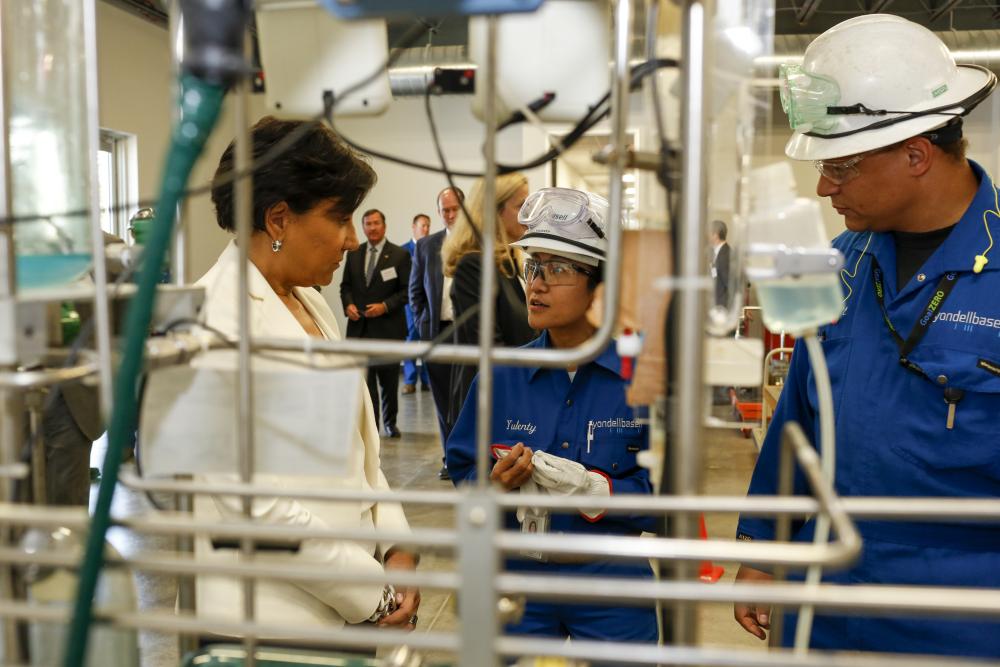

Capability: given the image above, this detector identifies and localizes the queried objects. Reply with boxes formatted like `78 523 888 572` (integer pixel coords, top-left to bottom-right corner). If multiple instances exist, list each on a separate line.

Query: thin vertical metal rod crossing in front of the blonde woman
469 16 497 490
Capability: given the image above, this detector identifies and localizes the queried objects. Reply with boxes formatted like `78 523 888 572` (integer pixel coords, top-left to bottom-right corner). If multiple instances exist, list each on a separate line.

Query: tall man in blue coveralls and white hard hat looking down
735 15 1000 657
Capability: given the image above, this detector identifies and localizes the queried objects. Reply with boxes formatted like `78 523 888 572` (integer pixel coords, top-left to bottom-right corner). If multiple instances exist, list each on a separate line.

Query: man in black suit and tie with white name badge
340 209 410 438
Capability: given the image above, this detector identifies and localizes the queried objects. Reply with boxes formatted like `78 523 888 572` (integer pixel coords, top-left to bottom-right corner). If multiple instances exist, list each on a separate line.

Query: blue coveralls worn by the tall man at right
737 161 1000 657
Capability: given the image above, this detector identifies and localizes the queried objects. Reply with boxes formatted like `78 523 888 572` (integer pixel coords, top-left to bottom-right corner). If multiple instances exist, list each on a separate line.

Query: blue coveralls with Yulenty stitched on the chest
446 332 657 641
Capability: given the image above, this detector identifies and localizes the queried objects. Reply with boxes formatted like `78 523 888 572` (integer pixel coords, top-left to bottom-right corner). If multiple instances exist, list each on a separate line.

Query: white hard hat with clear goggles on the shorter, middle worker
511 188 608 266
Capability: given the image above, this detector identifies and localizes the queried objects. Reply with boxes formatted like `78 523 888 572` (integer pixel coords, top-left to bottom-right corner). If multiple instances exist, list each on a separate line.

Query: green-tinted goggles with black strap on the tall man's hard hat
778 65 997 139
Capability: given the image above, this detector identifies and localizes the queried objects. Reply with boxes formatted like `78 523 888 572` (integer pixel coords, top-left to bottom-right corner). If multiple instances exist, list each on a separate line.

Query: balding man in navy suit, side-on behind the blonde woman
410 188 465 479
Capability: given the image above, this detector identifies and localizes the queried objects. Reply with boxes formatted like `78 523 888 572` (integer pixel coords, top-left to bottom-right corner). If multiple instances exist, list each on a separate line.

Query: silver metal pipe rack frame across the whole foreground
0 0 1000 667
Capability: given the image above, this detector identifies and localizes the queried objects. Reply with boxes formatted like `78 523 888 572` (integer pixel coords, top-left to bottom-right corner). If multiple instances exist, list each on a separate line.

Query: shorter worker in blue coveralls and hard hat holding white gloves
446 188 658 642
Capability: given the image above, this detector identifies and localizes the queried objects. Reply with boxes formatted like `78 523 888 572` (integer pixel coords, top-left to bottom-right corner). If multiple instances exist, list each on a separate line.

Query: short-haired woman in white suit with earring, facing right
195 117 420 639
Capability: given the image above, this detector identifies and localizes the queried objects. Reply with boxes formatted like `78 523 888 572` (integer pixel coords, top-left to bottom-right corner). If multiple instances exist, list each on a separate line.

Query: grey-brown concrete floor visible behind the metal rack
94 384 765 667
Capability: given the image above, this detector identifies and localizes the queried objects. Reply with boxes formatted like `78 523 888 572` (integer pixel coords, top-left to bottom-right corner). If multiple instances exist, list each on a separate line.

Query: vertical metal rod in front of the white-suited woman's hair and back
233 24 257 667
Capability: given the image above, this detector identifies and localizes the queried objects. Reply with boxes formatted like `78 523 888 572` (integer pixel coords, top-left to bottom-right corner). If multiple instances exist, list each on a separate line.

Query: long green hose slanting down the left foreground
63 75 226 667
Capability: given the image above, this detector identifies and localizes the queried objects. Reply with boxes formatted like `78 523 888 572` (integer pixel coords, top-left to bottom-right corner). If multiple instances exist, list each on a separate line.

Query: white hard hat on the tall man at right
781 14 997 160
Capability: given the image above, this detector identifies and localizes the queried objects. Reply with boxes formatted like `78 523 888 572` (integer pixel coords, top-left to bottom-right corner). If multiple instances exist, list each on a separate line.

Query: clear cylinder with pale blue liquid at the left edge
2 0 92 290
